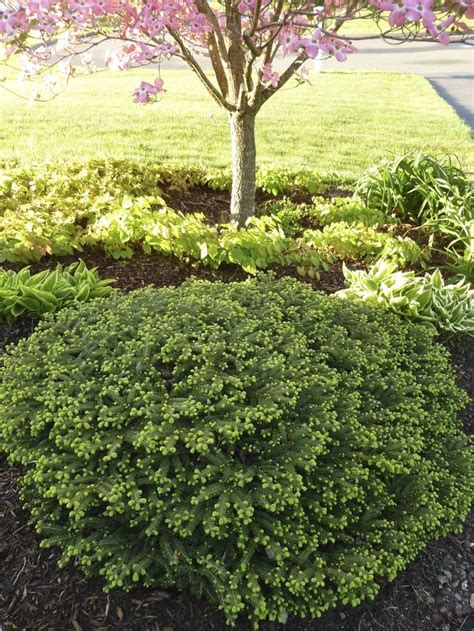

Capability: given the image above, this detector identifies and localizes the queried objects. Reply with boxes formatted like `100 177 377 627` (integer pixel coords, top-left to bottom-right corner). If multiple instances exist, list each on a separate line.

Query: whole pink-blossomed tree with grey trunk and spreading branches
0 0 474 225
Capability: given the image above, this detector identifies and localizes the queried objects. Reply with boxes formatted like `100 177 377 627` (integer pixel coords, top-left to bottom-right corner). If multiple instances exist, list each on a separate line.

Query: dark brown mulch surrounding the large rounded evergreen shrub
0 250 474 631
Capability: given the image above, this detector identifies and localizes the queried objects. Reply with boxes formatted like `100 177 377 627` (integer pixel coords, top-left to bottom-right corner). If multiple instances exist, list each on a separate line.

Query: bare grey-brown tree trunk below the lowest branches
230 112 256 226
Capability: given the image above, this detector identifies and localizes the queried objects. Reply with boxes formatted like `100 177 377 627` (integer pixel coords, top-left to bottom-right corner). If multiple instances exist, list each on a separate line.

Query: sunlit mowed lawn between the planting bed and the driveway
0 70 474 178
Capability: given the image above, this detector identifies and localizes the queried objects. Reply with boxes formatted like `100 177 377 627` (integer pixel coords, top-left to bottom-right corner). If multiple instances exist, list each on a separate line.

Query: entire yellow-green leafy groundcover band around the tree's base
0 160 422 275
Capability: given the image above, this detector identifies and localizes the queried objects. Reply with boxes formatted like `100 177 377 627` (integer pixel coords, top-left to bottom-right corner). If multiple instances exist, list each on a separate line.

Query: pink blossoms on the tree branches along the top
0 0 474 103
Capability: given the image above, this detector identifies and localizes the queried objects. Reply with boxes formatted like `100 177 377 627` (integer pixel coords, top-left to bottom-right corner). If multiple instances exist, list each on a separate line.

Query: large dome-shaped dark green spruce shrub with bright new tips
0 276 473 626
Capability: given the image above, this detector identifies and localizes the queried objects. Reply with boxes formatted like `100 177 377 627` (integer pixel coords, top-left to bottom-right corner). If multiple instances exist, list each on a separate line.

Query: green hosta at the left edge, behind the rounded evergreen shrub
0 261 112 322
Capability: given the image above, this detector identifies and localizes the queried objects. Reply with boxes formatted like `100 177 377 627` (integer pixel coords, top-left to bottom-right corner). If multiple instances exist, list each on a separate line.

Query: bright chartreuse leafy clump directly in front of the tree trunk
81 207 304 274
